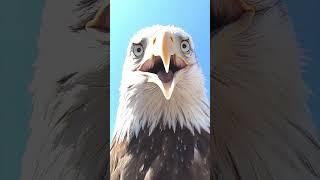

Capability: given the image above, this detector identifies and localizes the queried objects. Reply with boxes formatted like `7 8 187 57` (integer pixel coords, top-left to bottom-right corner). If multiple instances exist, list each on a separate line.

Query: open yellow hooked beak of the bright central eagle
139 31 188 100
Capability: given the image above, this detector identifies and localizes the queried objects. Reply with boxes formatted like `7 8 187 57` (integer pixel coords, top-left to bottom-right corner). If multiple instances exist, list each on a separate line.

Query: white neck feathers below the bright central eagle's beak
114 64 210 141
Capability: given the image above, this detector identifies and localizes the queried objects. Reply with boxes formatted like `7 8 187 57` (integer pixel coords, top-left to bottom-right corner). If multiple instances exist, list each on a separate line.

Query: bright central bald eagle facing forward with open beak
110 25 210 180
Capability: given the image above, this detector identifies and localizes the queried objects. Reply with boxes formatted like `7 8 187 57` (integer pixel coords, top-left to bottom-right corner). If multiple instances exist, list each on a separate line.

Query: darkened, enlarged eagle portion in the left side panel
21 0 110 180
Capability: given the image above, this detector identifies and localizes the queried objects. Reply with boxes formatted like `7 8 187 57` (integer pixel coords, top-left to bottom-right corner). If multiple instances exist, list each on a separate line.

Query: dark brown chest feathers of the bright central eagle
111 128 210 180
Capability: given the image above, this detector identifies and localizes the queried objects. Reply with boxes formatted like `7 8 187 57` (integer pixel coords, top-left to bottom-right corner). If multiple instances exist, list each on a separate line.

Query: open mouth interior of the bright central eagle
139 55 187 83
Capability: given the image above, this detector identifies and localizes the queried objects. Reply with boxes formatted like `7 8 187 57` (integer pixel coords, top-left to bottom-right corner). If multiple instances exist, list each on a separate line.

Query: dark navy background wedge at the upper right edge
287 0 320 129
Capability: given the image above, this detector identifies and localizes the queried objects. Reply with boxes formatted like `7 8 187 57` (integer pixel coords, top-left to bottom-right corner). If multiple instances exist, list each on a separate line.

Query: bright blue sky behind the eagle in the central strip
110 0 210 137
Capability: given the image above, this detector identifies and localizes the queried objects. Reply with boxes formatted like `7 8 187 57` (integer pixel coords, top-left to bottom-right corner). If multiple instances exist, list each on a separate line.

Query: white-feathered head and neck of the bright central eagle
116 25 209 143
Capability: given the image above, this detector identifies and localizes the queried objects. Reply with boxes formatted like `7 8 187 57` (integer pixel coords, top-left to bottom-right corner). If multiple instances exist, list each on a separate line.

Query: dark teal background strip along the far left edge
0 0 44 180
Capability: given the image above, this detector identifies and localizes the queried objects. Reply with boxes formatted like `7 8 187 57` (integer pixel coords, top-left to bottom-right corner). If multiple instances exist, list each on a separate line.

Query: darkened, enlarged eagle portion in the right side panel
210 0 320 180
